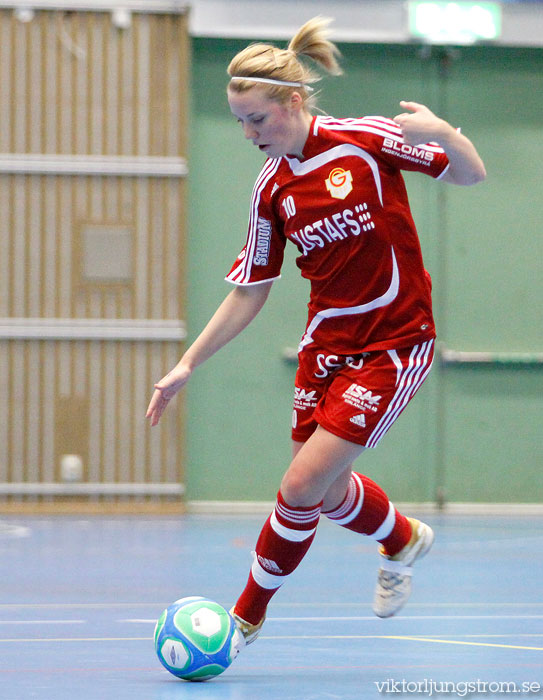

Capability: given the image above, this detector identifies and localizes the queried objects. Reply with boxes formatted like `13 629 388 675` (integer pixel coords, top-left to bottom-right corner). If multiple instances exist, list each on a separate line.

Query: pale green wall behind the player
184 39 543 502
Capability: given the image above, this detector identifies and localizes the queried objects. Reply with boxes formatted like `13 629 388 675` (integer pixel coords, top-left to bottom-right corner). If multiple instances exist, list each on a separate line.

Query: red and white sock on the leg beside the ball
235 492 321 625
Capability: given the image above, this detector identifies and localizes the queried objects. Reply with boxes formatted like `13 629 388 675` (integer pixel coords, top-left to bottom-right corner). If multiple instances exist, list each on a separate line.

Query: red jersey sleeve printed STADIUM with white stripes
225 159 286 285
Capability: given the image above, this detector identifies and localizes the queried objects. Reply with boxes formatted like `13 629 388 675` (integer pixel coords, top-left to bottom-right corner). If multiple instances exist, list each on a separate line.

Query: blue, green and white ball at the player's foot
155 596 245 681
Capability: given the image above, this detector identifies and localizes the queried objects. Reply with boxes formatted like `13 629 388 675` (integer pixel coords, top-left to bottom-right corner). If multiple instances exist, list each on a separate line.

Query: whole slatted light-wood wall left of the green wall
0 10 189 505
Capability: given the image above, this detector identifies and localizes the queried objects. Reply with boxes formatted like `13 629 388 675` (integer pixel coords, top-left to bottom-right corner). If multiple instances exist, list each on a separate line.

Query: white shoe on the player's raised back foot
373 518 434 617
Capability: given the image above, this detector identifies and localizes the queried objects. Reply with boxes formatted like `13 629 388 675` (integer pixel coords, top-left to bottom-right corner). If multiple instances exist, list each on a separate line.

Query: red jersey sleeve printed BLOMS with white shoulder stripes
361 117 449 180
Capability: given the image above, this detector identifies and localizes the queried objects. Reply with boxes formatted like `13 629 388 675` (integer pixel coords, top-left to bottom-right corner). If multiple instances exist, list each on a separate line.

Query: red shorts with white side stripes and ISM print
292 340 434 447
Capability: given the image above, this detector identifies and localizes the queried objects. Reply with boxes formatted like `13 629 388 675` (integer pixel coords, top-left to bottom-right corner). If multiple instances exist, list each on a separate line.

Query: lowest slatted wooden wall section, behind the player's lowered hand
0 340 183 493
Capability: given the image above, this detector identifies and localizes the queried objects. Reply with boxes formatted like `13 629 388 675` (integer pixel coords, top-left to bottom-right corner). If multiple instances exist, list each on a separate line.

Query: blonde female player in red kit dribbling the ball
147 18 485 643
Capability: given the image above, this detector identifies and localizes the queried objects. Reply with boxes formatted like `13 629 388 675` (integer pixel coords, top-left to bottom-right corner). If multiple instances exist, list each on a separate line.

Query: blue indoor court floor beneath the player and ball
0 513 543 700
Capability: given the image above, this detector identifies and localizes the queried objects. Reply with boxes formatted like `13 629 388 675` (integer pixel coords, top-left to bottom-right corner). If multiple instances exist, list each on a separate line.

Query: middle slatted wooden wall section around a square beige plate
0 175 185 318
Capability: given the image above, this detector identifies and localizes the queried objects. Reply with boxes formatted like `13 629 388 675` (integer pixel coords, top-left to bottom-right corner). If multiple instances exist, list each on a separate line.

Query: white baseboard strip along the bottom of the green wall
185 501 543 516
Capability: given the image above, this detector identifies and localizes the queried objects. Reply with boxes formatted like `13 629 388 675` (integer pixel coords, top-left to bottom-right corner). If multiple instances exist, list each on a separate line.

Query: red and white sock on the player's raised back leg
324 472 411 556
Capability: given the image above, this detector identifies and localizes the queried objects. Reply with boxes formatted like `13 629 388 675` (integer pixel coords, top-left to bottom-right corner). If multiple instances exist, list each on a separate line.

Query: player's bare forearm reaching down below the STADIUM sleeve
181 283 271 372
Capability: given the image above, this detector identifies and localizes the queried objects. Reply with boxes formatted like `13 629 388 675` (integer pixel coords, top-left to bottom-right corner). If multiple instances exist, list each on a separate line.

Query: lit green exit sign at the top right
408 2 501 44
